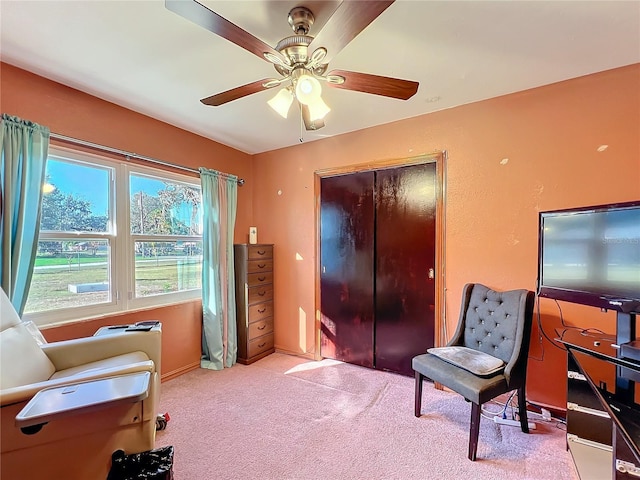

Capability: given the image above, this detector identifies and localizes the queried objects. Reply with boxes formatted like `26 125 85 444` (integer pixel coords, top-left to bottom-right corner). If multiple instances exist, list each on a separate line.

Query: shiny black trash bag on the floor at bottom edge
107 446 173 480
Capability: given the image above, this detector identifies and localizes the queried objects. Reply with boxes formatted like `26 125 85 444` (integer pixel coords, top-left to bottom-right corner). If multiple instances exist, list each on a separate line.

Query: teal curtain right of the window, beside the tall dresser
200 168 238 370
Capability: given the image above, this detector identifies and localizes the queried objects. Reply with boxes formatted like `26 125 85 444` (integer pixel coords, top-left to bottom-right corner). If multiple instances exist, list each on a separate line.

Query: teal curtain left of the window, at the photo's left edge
0 114 49 315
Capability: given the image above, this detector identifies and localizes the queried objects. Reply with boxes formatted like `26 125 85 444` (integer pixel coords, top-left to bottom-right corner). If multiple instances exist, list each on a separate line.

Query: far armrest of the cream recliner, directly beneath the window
41 330 162 372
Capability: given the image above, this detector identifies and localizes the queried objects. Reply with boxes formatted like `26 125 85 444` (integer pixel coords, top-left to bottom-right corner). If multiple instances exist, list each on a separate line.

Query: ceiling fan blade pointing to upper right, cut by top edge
308 0 393 63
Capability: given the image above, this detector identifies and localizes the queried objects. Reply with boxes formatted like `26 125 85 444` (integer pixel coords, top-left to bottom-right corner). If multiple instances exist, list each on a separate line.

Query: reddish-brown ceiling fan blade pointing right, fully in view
327 70 419 100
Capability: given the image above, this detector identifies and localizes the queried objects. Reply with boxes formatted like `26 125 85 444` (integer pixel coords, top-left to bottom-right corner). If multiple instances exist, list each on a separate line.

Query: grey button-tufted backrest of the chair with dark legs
449 283 534 383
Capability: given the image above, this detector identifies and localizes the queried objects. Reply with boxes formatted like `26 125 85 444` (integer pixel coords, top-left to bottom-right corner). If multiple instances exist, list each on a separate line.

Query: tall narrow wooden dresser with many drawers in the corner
233 244 275 365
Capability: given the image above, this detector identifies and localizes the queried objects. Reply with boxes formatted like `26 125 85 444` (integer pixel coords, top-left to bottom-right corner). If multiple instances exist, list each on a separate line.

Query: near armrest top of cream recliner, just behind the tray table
0 360 155 407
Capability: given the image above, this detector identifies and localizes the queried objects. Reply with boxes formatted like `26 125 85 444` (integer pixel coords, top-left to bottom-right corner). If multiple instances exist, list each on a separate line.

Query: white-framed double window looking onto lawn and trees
25 150 202 325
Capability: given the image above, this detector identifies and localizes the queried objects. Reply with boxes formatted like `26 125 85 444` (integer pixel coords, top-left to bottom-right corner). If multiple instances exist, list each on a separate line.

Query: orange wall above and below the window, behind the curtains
0 63 253 378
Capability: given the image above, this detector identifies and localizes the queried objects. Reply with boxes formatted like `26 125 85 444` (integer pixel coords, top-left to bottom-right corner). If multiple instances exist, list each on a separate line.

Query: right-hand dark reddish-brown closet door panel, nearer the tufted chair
375 163 436 375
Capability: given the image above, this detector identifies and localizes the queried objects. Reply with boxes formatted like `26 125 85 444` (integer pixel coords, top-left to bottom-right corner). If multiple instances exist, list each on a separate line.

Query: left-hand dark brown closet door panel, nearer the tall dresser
320 172 375 367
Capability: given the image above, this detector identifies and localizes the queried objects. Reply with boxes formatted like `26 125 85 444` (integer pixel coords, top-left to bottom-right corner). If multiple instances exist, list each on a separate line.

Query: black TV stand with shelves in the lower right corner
558 320 640 480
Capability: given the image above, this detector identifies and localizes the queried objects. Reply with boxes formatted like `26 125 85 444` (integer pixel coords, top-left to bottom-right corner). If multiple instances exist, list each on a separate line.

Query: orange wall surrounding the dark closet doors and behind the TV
253 65 640 406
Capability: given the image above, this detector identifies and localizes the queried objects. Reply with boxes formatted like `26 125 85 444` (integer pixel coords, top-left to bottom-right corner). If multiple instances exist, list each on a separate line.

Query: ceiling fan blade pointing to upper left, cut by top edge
164 0 286 63
